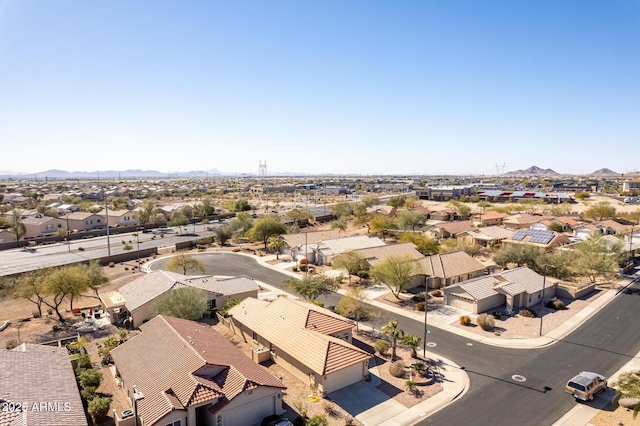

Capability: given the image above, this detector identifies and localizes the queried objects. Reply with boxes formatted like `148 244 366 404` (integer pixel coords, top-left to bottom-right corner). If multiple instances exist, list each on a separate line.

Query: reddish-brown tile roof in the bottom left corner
0 343 87 426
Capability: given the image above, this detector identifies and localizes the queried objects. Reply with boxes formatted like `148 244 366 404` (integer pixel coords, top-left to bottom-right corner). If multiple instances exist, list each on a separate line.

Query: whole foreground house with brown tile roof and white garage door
111 315 286 426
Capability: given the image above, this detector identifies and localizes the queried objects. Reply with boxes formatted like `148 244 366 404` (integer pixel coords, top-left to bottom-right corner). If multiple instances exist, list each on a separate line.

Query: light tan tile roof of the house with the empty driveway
229 297 371 375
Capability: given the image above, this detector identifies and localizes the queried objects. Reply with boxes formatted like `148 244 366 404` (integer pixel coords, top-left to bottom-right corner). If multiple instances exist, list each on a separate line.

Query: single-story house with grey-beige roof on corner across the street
443 267 556 314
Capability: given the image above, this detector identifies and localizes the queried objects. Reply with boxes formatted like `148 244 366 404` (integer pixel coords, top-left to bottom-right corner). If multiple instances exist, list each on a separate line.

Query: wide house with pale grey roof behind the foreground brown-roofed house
99 271 260 328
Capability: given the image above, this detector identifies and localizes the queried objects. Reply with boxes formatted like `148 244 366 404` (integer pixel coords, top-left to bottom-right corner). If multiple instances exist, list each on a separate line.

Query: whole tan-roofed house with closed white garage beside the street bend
228 297 372 395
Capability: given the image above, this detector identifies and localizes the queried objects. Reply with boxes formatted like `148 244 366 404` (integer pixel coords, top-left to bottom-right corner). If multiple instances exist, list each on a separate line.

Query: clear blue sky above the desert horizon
0 0 640 175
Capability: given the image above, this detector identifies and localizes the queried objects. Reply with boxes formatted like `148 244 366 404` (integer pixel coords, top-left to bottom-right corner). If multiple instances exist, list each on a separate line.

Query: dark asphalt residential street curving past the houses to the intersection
153 253 640 426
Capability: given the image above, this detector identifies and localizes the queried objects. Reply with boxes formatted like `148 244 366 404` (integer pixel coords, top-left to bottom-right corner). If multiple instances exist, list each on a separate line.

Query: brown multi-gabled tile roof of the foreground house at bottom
112 315 284 425
